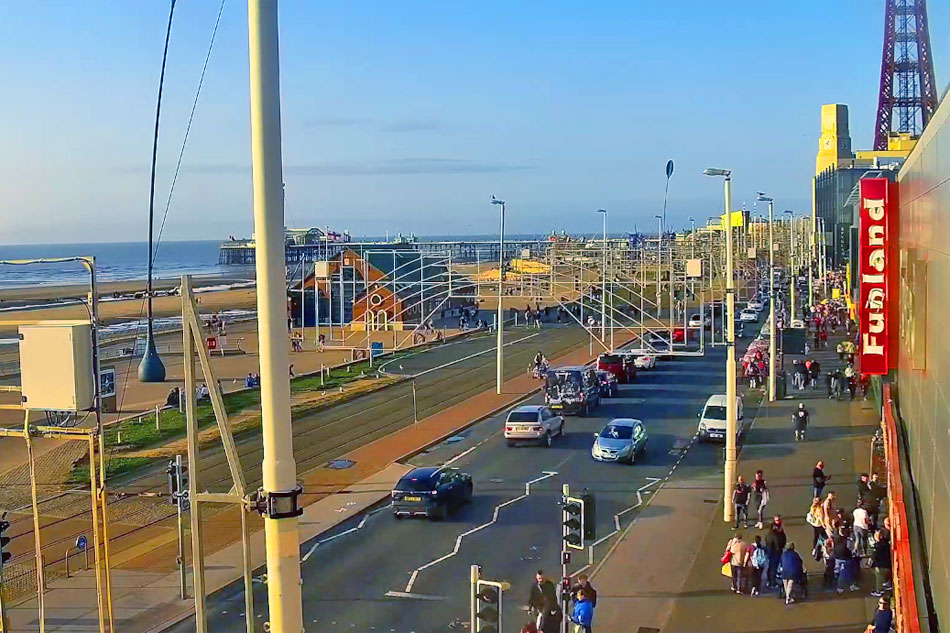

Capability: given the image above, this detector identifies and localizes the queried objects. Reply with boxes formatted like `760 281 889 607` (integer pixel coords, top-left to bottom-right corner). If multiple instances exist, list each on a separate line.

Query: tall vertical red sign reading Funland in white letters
857 178 897 375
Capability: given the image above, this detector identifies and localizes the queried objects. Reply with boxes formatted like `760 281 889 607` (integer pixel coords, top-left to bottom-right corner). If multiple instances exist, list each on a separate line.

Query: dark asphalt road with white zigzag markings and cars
165 326 753 633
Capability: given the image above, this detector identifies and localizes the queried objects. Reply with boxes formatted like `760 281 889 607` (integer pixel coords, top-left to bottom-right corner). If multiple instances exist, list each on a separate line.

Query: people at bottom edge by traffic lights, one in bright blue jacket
521 569 597 633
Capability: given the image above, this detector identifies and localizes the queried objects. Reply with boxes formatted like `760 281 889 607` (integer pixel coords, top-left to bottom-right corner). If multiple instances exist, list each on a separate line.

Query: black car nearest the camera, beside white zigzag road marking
392 466 473 519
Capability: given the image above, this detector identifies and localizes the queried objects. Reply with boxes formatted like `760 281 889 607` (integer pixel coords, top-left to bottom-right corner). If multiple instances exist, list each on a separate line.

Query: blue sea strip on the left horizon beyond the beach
0 240 232 288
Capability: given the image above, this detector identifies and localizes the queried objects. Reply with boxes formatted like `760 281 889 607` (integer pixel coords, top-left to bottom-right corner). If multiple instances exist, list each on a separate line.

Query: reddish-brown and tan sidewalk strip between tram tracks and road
8 328 608 632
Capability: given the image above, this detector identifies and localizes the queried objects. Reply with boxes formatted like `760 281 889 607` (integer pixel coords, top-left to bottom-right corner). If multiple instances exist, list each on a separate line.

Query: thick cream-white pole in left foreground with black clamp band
247 0 303 633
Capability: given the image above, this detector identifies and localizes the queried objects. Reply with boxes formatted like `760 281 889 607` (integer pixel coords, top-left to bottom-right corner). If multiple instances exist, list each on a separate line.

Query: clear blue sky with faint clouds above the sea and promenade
0 0 950 244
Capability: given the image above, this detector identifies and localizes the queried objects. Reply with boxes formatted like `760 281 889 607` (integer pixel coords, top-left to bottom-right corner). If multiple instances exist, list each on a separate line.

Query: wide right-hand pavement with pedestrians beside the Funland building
594 330 880 633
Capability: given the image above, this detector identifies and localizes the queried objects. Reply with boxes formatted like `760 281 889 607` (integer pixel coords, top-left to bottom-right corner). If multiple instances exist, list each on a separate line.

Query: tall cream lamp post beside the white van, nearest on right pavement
703 168 736 522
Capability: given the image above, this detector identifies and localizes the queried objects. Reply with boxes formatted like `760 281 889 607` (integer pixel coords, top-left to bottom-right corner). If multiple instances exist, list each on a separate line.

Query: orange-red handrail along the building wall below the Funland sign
881 384 921 633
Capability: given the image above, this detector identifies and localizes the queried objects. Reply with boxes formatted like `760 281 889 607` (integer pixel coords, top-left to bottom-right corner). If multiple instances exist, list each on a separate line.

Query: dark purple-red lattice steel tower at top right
874 0 937 151
